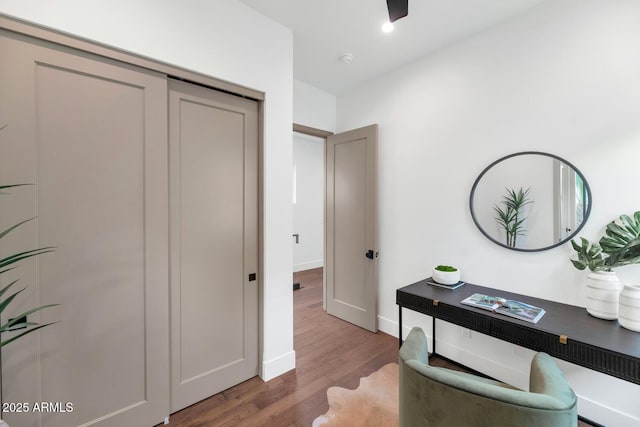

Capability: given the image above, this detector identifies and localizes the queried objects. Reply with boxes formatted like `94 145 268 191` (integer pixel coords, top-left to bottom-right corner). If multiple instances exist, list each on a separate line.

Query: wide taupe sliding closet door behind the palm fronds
0 32 169 427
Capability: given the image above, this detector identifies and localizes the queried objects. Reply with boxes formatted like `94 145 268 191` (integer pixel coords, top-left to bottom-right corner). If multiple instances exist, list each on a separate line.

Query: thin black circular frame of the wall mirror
469 151 593 252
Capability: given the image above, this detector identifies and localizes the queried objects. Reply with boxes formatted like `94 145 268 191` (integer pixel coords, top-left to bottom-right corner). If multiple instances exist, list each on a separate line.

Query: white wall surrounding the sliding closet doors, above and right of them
0 0 295 379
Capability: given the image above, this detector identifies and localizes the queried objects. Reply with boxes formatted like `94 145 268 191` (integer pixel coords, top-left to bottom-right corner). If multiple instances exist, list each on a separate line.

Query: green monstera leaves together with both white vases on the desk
571 211 640 331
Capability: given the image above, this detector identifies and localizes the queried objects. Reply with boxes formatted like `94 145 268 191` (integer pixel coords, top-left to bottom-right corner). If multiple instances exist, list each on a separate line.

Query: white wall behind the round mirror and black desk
337 0 640 426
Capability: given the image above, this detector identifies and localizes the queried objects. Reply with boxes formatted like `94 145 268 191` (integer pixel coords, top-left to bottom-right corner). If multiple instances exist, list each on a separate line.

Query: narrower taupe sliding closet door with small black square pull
169 81 259 412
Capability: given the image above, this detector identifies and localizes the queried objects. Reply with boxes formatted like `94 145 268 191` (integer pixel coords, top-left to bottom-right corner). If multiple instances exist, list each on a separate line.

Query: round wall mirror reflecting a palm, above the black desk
469 151 591 252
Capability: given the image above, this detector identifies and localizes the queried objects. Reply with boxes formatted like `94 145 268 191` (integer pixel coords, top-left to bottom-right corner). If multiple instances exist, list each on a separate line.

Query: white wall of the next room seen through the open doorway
293 132 324 271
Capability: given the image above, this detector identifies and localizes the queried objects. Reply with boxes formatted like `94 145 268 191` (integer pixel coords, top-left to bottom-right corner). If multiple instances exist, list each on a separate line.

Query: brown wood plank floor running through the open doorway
160 268 589 427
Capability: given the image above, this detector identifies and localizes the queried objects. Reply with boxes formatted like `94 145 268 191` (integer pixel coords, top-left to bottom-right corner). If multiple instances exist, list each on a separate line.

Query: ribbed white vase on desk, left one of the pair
587 271 620 320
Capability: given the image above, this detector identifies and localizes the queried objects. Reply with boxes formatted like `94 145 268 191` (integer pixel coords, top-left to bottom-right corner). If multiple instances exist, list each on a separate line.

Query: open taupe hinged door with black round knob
325 125 378 332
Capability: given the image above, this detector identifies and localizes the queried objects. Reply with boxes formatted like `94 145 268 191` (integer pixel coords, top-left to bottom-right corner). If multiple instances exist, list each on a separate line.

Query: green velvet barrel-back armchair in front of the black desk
399 328 578 427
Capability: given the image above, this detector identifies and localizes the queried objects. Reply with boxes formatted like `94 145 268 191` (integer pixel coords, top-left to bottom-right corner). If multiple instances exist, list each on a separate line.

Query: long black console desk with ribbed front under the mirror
396 279 640 384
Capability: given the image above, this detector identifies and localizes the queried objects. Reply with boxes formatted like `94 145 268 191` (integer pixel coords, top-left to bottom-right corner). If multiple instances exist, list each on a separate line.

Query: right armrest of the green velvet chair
529 352 577 408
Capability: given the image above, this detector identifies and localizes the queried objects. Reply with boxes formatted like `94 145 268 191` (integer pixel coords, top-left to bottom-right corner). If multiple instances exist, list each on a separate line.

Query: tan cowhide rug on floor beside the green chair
313 363 398 427
